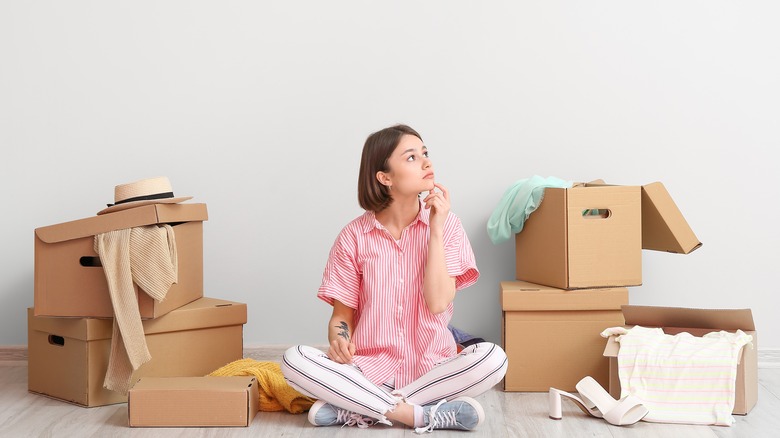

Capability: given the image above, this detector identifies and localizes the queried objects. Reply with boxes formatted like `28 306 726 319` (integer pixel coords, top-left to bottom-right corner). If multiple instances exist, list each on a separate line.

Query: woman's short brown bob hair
358 125 422 212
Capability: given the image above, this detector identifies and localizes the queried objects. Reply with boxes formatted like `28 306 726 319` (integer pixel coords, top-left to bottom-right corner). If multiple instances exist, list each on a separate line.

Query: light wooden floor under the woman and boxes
0 358 780 438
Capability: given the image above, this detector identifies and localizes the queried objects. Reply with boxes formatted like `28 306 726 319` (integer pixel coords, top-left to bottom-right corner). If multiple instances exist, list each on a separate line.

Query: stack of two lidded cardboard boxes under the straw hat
28 203 247 407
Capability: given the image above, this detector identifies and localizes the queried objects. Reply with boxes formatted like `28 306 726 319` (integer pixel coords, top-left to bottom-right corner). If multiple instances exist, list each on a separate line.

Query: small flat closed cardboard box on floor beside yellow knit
127 376 260 427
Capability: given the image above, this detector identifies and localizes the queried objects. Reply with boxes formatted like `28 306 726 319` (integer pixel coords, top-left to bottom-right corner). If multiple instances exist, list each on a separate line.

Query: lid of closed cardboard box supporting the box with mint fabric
501 281 628 311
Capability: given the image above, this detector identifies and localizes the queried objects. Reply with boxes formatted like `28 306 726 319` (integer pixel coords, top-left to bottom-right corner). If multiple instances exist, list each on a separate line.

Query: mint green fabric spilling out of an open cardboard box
487 175 572 245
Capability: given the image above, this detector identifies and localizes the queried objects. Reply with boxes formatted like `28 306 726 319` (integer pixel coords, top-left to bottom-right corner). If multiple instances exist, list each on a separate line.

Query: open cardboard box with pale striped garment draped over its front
604 306 758 415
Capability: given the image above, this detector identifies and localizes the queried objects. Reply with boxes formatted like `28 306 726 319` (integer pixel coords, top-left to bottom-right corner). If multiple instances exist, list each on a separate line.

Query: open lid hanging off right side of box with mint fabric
642 182 702 254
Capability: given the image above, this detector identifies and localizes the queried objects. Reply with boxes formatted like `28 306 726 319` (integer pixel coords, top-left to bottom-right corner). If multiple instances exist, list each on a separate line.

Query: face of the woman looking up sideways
379 134 434 195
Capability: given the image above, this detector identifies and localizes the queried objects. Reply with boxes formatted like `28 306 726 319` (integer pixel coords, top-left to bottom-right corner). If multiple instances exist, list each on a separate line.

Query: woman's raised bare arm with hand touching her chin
423 184 455 314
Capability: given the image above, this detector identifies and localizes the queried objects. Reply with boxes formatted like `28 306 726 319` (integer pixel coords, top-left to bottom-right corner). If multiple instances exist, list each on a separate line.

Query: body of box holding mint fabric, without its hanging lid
515 186 642 289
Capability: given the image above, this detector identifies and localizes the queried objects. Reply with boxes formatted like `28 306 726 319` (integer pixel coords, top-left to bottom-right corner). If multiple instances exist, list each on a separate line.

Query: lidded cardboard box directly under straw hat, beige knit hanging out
33 204 208 318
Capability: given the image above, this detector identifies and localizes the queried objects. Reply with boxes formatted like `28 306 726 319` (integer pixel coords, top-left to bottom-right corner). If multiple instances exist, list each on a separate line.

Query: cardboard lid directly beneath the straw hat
35 203 208 243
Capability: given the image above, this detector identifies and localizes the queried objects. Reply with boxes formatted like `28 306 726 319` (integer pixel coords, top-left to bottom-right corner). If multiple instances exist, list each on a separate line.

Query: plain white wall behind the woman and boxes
0 0 780 349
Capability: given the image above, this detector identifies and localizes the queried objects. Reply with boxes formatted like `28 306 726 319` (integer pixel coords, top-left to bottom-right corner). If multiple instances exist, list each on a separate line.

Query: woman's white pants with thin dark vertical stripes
281 342 507 420
